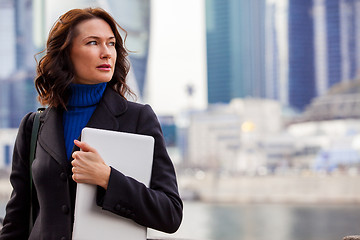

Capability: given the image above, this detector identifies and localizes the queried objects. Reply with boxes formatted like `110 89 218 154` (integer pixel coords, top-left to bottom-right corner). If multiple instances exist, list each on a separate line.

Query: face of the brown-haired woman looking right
70 18 117 84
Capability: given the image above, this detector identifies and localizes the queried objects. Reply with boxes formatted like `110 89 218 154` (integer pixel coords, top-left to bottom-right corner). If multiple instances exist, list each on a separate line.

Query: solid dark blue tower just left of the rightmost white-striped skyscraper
288 0 315 111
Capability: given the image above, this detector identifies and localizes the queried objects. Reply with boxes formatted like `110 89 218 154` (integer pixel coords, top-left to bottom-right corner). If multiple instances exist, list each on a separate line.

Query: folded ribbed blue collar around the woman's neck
67 82 107 107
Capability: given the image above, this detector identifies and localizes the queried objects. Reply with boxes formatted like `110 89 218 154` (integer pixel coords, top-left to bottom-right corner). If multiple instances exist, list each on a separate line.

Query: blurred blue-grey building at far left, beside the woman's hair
0 0 36 128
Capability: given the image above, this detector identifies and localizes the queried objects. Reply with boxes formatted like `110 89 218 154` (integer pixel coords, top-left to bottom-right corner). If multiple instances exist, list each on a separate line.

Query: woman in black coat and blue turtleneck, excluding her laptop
0 8 182 240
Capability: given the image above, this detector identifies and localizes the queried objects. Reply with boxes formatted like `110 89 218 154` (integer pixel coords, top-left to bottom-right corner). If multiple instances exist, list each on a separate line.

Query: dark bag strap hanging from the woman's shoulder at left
29 108 45 234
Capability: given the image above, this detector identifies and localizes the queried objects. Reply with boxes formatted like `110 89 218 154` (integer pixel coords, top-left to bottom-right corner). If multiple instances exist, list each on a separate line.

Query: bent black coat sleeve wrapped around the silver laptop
98 105 183 233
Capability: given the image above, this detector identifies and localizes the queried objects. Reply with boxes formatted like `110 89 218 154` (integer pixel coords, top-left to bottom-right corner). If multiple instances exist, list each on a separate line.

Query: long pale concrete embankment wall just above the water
178 173 360 203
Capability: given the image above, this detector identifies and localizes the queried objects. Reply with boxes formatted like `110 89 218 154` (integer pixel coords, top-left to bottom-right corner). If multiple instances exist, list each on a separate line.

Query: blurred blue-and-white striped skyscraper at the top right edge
314 0 360 95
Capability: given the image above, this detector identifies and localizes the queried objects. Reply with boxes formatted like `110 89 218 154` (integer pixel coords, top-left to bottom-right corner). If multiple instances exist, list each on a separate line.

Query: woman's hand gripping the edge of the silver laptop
71 140 111 189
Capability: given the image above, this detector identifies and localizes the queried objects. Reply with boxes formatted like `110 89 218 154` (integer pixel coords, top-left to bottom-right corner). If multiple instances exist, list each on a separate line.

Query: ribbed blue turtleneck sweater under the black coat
63 83 107 159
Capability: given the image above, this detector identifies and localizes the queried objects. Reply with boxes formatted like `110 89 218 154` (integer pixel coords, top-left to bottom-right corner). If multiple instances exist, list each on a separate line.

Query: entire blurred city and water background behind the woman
0 0 360 240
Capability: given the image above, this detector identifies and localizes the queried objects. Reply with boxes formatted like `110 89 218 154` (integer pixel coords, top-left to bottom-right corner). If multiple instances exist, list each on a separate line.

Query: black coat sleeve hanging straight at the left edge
0 113 33 240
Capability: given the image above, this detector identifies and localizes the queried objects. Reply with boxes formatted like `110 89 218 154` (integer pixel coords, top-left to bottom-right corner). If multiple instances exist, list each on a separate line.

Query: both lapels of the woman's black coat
38 86 127 165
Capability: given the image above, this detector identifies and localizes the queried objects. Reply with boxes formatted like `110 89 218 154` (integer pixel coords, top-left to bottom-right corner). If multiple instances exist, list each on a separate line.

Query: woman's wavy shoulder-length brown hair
35 8 135 109
